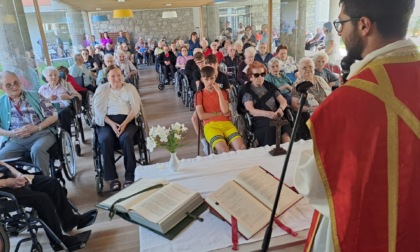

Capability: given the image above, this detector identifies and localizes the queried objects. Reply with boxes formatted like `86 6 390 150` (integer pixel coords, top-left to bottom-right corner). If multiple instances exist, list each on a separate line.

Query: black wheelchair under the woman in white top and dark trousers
92 112 150 195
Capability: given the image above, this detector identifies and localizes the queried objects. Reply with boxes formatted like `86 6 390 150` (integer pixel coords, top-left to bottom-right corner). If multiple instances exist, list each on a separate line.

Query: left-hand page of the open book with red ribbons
206 181 270 238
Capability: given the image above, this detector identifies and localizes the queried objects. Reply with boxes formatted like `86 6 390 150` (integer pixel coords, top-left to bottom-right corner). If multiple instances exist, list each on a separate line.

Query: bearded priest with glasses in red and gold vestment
295 0 420 252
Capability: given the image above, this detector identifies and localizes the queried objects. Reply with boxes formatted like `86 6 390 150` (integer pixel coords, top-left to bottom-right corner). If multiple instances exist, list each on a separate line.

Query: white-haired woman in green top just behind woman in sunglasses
265 57 293 105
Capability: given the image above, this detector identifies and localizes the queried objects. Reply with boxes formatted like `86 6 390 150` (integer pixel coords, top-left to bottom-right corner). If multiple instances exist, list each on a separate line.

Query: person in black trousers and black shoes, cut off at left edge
0 160 98 251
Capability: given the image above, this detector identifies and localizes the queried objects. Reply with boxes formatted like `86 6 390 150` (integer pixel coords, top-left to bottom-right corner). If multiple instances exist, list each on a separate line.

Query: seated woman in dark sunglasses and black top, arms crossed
239 61 290 146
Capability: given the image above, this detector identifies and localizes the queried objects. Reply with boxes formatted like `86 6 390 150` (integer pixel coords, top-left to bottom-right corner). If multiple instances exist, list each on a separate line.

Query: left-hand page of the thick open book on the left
98 179 168 211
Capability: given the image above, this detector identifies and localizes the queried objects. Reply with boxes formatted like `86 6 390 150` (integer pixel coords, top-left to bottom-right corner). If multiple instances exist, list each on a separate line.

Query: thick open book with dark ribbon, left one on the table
97 179 206 239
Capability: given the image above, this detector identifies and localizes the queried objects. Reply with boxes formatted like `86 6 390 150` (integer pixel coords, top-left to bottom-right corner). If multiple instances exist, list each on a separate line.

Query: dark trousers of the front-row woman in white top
98 115 138 181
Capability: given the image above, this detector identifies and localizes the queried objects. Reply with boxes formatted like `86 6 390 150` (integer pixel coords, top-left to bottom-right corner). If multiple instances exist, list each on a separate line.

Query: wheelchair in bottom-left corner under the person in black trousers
0 160 77 252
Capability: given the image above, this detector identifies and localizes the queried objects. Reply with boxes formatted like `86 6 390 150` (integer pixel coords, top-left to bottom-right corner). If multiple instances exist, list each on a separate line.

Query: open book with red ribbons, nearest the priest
205 166 302 239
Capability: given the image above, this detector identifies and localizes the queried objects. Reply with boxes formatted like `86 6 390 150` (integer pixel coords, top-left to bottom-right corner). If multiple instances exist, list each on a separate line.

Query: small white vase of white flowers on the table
147 122 188 171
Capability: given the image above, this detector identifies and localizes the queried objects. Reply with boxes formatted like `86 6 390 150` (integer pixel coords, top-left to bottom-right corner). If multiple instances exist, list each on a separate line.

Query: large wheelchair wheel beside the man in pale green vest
60 130 76 181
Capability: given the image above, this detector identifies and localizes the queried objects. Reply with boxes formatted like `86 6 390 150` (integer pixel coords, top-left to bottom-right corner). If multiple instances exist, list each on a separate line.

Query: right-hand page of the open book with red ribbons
235 166 302 215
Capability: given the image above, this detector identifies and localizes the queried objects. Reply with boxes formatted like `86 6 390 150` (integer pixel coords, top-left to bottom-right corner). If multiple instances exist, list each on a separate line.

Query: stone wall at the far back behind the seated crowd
92 8 195 44
